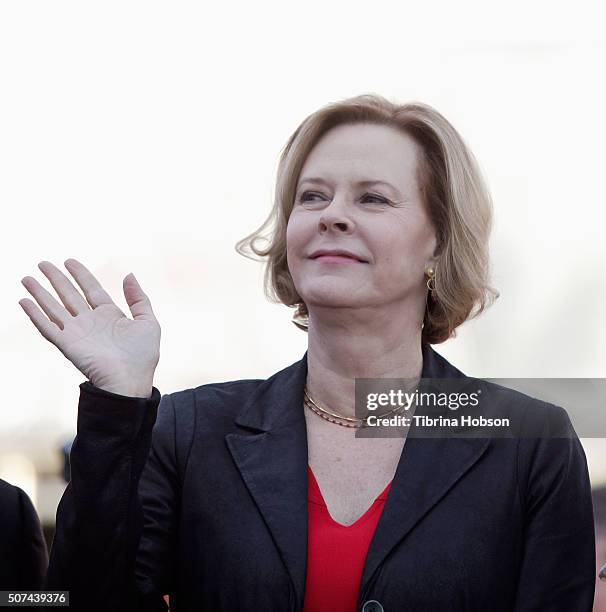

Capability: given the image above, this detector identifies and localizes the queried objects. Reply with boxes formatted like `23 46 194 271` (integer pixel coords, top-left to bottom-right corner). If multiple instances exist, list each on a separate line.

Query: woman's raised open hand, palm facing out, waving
19 259 160 397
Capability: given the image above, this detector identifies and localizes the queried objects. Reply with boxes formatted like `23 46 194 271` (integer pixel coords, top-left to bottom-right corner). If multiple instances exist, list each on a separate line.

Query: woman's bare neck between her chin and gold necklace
307 309 423 416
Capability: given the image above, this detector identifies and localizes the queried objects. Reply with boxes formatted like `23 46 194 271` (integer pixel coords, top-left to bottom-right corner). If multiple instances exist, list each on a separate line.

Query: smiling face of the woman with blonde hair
286 119 437 319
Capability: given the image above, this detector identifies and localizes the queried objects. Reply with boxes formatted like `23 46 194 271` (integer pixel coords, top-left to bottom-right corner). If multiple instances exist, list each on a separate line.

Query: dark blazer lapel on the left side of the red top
225 352 308 609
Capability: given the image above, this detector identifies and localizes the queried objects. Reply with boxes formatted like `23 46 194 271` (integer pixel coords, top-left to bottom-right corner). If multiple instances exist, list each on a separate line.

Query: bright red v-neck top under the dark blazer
303 466 393 612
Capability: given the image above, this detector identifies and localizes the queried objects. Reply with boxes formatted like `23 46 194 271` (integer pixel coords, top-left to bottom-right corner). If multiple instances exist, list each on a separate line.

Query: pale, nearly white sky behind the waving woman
0 1 606 512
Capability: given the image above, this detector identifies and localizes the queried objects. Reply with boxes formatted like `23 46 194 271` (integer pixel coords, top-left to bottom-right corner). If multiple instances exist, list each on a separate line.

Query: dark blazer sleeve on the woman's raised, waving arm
45 381 178 612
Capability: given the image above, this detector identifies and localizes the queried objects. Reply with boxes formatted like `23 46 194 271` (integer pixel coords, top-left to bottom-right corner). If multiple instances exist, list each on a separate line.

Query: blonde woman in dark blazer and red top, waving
20 95 595 612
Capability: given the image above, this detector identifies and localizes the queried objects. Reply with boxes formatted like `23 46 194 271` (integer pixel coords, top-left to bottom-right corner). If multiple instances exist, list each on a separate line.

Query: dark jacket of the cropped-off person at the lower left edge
0 480 48 591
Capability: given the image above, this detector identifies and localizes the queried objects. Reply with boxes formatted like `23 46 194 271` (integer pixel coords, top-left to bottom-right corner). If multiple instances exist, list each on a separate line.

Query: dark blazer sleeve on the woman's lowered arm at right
515 404 596 612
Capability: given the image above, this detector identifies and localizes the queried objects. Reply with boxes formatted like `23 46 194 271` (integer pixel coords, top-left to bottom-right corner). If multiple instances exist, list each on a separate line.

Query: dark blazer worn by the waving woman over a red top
47 344 595 612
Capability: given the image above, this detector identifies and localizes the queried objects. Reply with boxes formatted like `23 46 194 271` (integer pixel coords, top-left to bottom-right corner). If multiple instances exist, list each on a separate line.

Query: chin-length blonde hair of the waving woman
236 94 499 344
